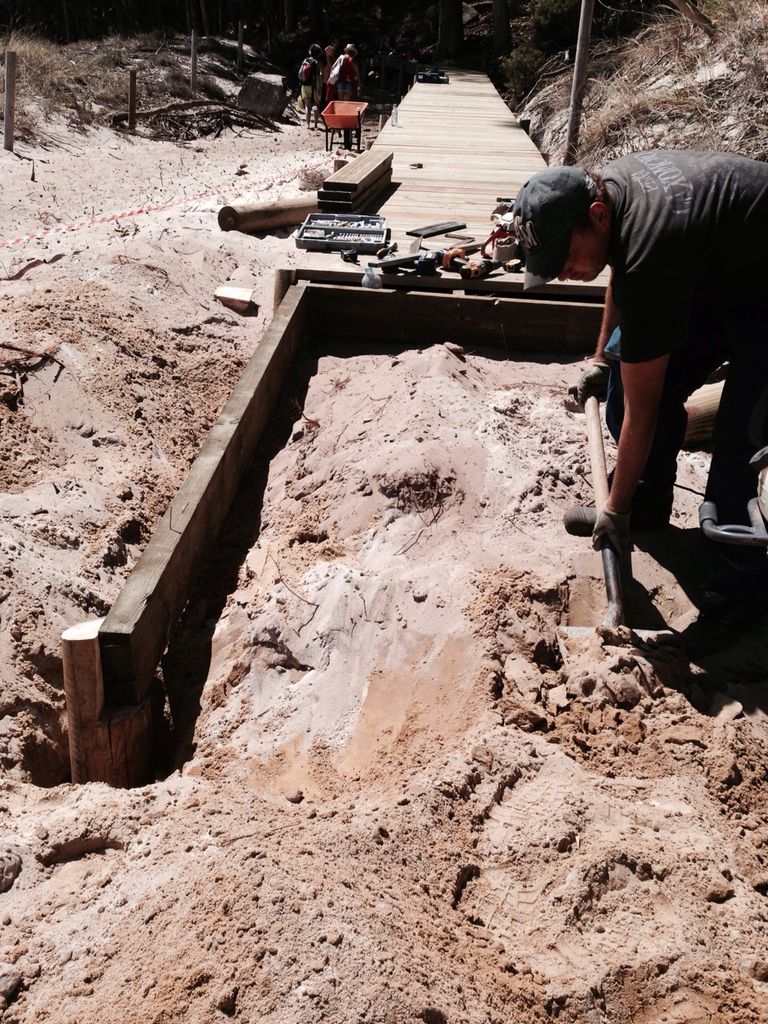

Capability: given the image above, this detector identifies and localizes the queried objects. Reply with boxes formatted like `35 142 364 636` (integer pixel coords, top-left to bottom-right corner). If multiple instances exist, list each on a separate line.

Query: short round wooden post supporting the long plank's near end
61 618 152 787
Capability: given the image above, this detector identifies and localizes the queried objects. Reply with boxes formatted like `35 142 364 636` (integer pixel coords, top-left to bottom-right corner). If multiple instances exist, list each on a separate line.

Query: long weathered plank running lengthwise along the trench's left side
98 284 307 705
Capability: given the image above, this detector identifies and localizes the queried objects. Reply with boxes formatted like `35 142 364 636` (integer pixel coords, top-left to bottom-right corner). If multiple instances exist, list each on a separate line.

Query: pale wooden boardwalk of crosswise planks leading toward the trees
297 71 607 298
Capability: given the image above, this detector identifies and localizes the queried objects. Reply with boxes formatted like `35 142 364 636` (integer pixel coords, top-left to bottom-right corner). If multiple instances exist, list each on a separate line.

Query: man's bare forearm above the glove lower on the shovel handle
607 355 670 514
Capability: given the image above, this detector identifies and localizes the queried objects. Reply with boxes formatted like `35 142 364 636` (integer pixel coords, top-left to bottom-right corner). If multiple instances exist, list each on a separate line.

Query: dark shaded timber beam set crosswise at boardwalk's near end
307 282 602 353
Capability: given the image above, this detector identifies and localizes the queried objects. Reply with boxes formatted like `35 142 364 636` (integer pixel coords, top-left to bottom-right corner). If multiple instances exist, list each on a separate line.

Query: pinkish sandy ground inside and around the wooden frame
0 112 768 1024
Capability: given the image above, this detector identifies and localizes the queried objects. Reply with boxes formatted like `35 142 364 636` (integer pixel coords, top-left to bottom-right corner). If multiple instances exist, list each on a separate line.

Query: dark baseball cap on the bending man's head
514 167 597 289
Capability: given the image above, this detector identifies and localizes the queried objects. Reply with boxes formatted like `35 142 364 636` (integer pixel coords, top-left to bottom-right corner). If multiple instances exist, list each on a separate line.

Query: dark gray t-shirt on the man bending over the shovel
602 150 768 362
